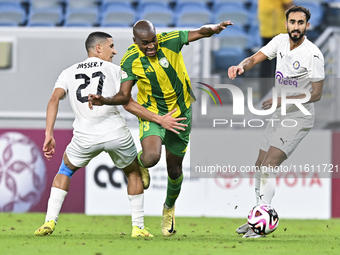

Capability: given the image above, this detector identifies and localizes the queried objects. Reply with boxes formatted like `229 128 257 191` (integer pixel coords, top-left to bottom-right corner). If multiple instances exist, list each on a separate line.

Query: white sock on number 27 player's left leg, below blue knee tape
45 187 67 224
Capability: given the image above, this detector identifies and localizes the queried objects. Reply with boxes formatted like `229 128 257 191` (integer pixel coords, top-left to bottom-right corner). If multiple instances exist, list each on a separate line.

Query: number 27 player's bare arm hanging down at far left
43 88 65 160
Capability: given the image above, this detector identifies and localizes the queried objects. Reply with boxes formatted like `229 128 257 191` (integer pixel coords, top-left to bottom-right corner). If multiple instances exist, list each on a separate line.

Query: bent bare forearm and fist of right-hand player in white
228 51 267 80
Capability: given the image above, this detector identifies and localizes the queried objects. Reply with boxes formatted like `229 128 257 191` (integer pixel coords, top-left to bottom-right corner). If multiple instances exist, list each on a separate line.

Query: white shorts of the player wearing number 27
66 129 137 169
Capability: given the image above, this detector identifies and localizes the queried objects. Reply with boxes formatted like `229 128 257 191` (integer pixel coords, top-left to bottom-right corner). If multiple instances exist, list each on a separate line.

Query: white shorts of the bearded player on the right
260 118 311 158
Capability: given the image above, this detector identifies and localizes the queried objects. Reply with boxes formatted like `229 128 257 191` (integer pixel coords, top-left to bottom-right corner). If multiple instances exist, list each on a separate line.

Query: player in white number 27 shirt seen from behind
35 32 152 237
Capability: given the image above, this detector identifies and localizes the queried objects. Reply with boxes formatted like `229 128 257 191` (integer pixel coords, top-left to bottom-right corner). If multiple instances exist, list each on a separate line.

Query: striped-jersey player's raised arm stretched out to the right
188 20 233 42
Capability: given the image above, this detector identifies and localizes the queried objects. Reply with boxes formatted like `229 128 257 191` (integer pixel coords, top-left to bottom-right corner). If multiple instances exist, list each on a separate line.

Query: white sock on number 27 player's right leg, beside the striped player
128 193 144 229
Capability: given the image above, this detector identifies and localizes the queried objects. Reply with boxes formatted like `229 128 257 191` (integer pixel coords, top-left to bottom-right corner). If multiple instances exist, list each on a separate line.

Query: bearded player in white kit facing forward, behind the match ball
228 6 325 238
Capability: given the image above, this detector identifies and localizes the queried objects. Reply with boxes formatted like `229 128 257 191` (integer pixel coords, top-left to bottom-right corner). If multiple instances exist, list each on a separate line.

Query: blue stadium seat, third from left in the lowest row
64 7 99 27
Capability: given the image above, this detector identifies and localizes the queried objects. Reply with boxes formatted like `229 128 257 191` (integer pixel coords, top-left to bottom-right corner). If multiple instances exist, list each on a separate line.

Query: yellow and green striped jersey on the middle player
120 31 192 117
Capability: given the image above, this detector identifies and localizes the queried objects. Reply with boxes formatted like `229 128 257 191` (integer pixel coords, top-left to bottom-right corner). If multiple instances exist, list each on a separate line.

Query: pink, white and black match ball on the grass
248 205 279 235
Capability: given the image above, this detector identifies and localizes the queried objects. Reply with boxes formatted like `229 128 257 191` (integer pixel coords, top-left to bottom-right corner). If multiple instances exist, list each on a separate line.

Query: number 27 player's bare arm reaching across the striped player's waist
123 98 188 134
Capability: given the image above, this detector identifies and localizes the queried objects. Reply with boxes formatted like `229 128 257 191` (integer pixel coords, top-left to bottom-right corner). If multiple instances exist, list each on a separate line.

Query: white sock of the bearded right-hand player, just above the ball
259 166 276 205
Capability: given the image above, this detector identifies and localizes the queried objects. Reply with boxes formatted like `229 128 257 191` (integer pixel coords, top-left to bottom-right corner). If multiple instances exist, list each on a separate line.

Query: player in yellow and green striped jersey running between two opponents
89 20 232 236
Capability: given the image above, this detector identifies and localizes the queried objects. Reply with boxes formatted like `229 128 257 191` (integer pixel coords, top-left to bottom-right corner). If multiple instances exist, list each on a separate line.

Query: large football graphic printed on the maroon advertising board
0 132 46 212
